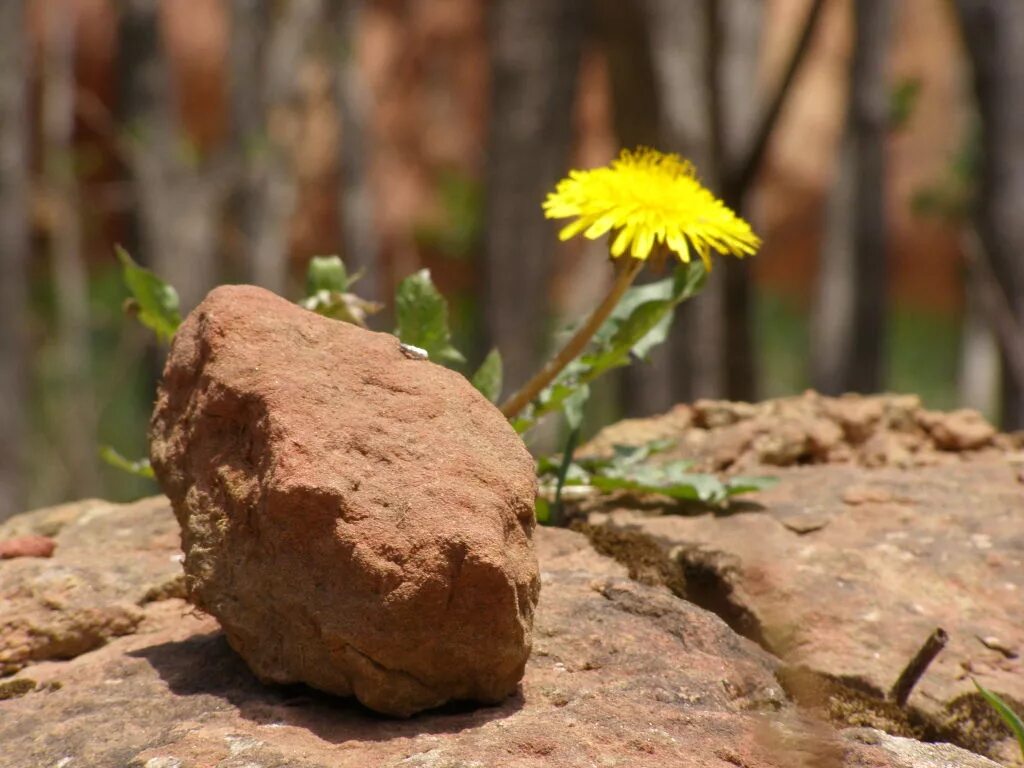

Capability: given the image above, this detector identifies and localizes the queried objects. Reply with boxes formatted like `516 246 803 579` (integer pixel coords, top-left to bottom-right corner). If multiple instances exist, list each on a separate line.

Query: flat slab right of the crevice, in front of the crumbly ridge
589 456 1024 765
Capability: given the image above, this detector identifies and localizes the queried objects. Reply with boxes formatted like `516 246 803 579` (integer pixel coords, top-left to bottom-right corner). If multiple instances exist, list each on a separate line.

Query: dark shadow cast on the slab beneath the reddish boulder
131 632 524 743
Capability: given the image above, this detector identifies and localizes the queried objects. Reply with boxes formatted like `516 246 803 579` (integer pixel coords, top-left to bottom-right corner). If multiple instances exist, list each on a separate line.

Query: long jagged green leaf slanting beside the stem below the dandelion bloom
512 261 708 433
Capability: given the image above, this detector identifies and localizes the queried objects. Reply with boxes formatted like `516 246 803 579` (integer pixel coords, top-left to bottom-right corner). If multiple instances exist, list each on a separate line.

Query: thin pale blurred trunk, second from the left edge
42 0 99 498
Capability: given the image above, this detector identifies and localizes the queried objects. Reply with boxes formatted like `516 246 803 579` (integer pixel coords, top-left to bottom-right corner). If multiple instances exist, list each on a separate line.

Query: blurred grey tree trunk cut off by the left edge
0 0 30 521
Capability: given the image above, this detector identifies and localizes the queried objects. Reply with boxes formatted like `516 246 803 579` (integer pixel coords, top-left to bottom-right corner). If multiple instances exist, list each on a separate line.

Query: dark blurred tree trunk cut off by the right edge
956 0 1024 429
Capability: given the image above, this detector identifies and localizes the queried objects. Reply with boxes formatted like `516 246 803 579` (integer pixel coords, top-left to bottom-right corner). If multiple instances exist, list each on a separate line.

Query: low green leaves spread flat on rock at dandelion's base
538 440 777 515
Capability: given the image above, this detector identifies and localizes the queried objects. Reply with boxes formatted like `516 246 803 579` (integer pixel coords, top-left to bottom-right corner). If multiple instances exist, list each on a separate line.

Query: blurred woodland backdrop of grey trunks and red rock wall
0 0 1024 518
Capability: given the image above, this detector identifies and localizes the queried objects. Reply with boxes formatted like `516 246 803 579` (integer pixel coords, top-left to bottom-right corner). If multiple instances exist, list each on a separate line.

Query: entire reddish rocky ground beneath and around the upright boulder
0 396 1024 768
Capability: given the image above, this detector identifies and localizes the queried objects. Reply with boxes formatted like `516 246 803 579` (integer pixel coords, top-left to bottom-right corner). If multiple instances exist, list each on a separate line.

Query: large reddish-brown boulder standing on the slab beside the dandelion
151 286 540 716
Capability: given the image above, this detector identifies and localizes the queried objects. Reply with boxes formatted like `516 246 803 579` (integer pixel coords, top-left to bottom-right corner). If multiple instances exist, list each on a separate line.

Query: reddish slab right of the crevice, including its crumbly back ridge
580 395 1024 762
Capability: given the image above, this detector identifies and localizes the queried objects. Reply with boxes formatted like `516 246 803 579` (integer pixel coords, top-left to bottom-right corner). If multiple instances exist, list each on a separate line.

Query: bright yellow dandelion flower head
544 147 761 268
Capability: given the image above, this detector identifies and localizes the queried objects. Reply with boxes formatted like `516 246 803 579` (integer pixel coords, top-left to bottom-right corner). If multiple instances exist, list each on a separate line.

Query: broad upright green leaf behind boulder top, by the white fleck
394 269 466 367
